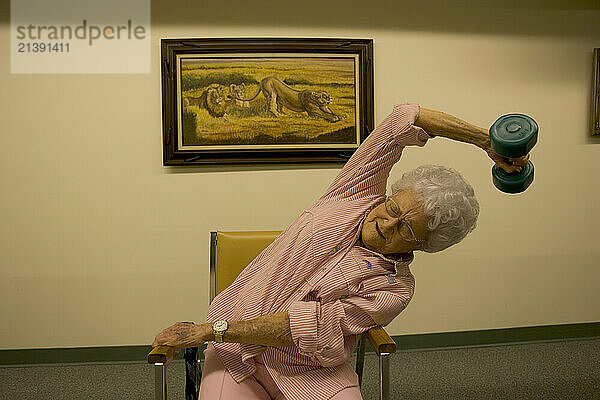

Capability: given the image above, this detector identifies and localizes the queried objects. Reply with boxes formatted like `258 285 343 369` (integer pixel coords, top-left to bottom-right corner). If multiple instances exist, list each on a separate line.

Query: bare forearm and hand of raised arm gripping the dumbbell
415 107 529 173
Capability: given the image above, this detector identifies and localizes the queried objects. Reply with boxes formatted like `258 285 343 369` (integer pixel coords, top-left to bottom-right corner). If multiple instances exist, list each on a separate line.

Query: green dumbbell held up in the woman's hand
490 114 538 193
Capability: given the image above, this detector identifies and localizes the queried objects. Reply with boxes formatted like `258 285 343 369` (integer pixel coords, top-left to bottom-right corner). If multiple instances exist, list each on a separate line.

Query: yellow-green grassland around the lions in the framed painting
181 58 356 146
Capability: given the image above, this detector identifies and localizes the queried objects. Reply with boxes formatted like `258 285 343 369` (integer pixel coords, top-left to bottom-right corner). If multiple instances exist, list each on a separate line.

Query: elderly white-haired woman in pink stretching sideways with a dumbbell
153 104 528 400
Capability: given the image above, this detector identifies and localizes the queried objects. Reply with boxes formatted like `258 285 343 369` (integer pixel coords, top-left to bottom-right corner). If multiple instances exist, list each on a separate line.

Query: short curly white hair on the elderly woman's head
392 165 479 253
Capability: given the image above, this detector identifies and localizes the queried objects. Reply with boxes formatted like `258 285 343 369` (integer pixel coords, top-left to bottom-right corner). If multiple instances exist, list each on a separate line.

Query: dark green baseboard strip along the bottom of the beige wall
0 322 600 365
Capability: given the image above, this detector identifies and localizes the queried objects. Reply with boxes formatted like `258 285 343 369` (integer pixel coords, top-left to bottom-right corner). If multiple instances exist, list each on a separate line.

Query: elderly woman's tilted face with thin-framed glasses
361 190 429 254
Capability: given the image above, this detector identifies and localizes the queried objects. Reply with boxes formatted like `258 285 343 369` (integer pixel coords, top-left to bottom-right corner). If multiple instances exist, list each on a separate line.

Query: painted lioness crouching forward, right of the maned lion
236 76 341 122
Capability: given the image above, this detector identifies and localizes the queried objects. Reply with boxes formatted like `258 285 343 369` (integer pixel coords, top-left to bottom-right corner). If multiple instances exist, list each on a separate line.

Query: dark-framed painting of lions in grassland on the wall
161 38 373 165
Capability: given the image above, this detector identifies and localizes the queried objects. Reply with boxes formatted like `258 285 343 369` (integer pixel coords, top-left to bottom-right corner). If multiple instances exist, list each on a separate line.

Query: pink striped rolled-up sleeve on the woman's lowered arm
288 275 414 367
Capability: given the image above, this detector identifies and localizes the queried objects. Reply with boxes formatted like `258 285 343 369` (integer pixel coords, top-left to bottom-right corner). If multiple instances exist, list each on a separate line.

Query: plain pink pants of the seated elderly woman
200 344 362 400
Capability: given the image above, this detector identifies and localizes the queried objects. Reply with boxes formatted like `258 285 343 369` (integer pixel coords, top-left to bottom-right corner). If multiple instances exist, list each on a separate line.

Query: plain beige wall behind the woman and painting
0 0 600 348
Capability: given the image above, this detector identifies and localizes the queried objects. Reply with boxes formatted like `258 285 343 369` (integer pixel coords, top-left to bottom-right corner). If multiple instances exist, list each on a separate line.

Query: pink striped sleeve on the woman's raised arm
321 103 432 200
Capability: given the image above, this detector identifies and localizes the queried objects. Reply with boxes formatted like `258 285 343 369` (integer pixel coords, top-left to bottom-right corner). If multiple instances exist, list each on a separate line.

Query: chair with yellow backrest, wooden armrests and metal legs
148 231 396 400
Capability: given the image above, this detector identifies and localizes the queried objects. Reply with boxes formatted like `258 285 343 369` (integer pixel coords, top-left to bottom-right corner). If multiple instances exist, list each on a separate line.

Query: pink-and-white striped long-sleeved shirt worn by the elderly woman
207 104 430 400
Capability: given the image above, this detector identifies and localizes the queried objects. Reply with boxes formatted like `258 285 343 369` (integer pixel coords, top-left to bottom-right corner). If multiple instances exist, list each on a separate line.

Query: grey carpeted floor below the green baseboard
0 338 600 400
